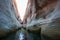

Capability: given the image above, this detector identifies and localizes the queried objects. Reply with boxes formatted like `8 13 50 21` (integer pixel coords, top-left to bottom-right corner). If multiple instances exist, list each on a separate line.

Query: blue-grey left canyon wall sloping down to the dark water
0 0 21 37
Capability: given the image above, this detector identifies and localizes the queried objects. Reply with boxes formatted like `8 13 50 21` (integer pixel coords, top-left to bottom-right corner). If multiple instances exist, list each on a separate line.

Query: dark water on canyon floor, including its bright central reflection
0 30 41 40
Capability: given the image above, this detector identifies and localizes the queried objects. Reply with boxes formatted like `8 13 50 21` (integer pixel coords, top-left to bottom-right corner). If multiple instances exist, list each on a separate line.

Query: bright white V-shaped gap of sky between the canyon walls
16 0 28 21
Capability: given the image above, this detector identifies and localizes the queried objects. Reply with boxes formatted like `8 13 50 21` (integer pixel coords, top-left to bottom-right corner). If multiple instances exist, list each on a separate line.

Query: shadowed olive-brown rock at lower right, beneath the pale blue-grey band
41 18 60 40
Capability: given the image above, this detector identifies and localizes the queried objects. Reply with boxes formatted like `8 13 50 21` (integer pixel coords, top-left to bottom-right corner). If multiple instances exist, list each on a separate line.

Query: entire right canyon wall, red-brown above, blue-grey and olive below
24 0 60 40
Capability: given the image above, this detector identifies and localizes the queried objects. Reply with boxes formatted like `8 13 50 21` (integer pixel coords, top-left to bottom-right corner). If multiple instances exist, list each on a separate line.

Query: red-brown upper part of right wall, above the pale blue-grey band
24 0 57 23
